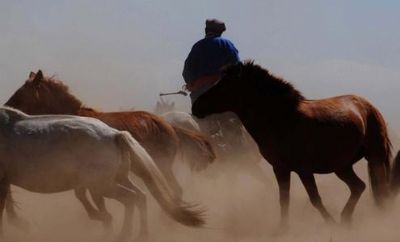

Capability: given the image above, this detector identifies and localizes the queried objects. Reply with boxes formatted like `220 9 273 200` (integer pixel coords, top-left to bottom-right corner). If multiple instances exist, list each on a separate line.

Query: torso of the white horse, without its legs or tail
0 112 121 192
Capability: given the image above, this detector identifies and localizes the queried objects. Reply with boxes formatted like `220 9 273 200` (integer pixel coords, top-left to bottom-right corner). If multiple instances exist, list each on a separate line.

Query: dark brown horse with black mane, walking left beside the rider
192 62 391 225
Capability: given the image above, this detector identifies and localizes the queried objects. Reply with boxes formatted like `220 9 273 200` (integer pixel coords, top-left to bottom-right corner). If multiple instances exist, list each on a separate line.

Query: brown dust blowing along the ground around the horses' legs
4 150 400 242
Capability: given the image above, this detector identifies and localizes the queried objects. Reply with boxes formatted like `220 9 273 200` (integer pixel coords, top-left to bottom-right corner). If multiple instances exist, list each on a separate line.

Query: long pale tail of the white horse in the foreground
118 131 205 227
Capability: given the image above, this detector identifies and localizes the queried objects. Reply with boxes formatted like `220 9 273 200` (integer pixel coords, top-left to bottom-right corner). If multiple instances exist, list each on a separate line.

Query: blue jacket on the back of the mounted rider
182 36 240 101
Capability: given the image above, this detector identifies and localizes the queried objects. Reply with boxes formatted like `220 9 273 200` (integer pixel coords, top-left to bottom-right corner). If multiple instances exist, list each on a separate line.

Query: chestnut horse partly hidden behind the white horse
5 70 215 233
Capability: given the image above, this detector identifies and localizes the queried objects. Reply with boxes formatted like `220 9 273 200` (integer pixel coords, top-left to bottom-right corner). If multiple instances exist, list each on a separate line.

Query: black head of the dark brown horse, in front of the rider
192 63 246 118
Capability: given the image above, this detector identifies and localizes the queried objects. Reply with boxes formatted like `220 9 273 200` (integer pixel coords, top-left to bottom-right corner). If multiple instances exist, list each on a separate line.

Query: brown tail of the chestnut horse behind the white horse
173 126 216 171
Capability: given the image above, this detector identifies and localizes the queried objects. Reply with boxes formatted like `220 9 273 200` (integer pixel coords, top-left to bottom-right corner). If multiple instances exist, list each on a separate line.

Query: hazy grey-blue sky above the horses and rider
0 0 400 132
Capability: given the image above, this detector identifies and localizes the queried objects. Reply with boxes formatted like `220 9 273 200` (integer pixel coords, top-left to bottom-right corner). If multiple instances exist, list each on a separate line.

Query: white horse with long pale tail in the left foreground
0 107 204 239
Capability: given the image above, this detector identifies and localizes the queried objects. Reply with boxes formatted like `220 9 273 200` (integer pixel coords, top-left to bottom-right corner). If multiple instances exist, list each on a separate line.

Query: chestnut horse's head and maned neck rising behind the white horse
5 70 81 114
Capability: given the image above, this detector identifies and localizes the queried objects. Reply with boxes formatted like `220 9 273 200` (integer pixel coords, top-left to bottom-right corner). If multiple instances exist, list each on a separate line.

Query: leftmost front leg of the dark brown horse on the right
274 167 290 228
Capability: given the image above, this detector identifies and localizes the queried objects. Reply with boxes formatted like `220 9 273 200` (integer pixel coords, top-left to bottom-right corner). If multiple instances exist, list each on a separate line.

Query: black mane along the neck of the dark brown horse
241 61 305 104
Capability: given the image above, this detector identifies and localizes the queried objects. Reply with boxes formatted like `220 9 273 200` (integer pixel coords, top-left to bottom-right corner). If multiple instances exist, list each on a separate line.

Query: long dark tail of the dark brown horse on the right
365 105 392 207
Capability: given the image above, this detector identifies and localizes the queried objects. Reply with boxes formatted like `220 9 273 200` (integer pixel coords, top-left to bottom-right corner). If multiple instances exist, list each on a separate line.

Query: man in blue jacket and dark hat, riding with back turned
182 19 241 155
